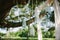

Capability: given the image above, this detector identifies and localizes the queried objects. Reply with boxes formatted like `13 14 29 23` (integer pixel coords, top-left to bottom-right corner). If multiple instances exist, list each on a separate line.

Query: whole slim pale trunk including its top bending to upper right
35 0 53 40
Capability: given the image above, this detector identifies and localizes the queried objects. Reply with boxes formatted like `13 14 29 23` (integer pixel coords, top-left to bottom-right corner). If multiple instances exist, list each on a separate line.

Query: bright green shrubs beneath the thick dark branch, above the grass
9 29 28 37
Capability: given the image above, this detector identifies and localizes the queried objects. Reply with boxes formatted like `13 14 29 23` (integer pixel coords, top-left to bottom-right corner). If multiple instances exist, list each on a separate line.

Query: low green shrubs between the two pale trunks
42 27 55 38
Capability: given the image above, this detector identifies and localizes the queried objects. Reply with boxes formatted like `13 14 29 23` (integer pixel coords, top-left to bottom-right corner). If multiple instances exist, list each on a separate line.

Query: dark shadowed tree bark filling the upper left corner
0 0 27 20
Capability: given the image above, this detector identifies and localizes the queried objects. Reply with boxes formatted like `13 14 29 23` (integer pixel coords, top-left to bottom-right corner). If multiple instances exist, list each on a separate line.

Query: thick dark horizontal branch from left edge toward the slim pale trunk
0 17 35 27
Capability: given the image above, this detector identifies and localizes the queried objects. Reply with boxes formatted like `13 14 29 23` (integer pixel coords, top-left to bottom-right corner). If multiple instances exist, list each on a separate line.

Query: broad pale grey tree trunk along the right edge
54 0 60 40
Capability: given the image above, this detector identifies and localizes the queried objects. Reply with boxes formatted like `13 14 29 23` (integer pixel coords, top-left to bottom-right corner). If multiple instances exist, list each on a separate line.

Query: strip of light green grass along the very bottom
0 37 55 40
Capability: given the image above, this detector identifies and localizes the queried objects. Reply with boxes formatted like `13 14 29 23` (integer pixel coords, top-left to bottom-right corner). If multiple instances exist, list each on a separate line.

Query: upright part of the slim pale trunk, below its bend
35 7 42 40
